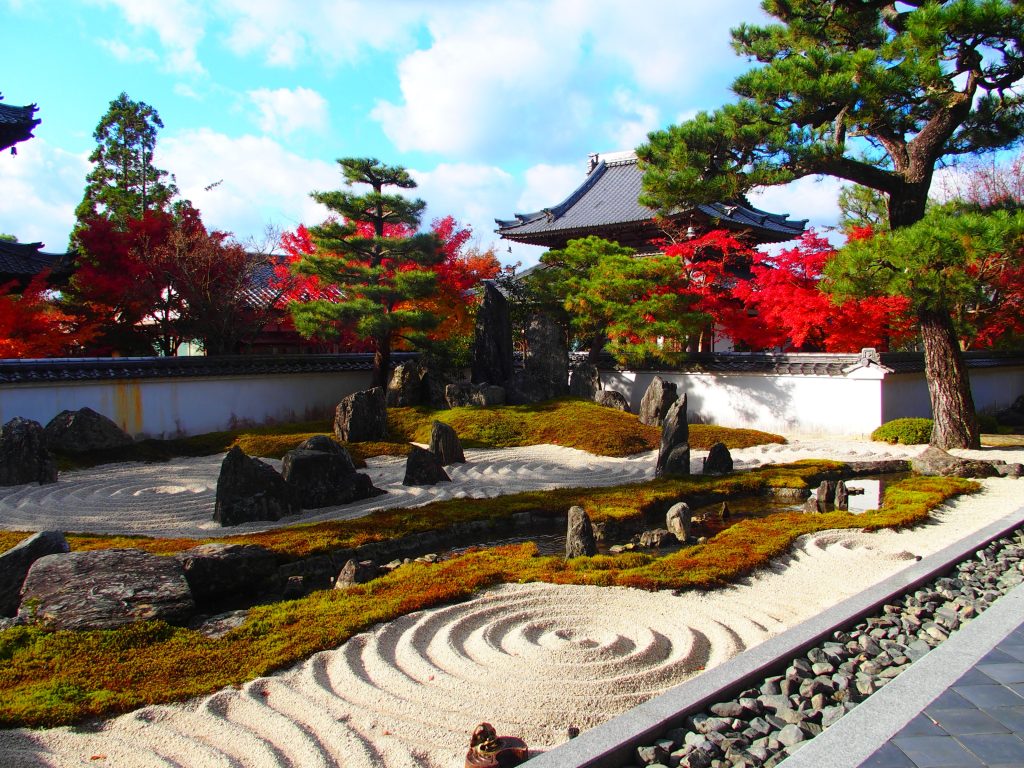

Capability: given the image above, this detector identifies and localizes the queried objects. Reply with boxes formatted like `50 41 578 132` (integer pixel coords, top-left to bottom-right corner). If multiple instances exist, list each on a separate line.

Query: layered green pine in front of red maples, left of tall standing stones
291 158 444 386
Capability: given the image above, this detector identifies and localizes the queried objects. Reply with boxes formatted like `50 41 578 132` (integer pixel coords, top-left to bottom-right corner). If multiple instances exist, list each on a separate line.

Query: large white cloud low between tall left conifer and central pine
156 128 343 240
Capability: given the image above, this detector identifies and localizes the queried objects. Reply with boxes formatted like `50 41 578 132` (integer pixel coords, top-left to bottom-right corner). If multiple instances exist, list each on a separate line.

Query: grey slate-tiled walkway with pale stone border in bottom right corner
781 585 1024 768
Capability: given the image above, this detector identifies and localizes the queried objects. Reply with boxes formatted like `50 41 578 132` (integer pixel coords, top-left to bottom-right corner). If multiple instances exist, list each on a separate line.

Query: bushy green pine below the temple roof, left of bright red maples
534 237 710 366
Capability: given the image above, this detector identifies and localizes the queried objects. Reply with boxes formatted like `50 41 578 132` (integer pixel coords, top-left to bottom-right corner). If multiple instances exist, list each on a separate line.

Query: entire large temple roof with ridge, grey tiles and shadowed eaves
495 152 807 250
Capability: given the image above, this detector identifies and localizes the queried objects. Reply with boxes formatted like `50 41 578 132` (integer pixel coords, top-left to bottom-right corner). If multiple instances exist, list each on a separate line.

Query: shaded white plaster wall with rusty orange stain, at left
0 371 371 437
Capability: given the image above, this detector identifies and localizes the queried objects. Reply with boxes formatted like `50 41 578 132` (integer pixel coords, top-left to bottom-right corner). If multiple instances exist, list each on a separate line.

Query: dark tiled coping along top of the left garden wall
0 352 416 384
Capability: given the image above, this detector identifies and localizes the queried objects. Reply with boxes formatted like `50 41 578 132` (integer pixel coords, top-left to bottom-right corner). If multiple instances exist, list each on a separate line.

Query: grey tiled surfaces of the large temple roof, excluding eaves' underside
495 155 807 242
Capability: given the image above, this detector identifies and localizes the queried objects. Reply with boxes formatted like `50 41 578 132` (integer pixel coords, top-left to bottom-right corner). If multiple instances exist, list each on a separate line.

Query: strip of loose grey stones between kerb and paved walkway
618 528 1024 768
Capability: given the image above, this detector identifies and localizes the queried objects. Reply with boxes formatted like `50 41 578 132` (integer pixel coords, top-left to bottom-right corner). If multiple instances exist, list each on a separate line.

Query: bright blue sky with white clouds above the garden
0 0 839 265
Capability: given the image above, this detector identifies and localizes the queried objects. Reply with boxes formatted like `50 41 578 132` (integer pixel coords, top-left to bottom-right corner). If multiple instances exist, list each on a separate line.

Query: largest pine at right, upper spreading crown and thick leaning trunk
638 0 1024 446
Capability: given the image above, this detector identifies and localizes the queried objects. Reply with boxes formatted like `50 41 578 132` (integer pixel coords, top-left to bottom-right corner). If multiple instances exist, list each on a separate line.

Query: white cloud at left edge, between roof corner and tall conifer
0 138 89 253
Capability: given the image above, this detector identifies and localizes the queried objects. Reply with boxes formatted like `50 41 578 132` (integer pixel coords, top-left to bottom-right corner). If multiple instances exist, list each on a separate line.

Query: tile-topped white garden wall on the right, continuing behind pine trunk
601 350 1024 436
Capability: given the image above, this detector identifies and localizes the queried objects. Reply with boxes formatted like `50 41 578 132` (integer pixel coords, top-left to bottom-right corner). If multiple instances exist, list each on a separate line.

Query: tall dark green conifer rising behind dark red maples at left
72 93 177 241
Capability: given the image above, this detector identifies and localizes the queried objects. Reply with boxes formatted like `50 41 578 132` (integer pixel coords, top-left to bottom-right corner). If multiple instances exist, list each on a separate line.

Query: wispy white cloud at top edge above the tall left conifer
93 0 206 75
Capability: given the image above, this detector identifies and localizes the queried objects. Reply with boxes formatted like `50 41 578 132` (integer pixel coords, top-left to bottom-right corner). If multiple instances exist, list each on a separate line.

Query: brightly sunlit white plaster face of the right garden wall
601 371 882 435
